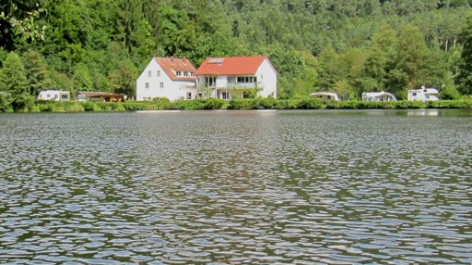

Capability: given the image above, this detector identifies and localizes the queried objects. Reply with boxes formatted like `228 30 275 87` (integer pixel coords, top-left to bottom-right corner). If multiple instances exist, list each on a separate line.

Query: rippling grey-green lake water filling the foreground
0 110 472 265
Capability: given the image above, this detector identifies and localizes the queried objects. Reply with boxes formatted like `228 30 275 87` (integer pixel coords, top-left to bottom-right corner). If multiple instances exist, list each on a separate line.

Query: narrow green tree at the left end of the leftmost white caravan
23 50 52 96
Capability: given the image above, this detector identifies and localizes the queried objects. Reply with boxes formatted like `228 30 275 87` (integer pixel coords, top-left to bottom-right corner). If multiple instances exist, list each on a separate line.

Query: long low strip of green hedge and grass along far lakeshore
0 98 472 112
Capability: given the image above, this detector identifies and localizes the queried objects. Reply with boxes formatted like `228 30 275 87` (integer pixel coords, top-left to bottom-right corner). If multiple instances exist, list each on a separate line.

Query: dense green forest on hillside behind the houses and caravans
0 0 472 109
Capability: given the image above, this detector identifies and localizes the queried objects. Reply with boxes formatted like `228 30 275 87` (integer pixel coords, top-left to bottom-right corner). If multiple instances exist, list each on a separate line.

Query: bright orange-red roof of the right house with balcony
195 56 267 75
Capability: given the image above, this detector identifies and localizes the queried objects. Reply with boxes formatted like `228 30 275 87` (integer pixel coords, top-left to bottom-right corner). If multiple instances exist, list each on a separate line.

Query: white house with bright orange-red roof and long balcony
195 56 278 99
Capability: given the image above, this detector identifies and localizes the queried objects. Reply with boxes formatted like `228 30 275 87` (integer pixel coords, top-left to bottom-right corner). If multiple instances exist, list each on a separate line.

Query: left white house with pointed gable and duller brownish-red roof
136 57 197 101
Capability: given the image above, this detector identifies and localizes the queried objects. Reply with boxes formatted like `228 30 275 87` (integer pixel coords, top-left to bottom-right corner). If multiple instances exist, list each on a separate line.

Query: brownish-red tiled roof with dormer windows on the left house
154 57 196 81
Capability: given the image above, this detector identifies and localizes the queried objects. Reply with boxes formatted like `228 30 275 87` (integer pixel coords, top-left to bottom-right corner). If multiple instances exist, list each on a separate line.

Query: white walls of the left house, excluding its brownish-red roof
136 59 197 101
